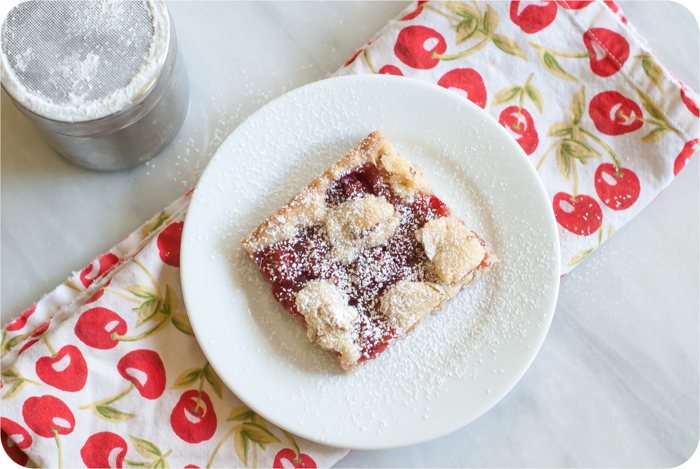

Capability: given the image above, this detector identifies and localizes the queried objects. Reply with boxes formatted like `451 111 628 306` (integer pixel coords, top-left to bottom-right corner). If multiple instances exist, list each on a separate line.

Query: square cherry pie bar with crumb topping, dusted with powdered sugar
241 132 496 371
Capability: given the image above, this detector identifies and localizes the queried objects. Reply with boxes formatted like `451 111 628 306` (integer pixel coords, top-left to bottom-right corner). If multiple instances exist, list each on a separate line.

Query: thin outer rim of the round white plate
180 74 561 450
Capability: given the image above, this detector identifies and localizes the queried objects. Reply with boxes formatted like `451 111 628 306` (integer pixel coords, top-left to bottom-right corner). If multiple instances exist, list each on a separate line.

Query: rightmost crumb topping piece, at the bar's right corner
416 217 486 284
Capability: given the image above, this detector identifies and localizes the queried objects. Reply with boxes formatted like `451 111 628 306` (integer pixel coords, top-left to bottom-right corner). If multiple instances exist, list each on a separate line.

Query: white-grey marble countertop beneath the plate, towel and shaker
0 1 700 467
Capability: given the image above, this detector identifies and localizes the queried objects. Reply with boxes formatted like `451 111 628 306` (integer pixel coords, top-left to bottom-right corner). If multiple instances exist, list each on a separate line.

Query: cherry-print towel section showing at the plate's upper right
337 0 698 275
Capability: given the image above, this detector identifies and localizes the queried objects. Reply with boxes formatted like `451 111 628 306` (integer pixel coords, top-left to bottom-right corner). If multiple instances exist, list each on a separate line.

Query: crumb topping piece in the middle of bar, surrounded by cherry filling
326 195 401 264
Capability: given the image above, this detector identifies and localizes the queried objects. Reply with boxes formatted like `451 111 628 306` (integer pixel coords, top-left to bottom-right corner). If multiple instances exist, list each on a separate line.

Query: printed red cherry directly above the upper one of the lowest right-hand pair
588 91 644 135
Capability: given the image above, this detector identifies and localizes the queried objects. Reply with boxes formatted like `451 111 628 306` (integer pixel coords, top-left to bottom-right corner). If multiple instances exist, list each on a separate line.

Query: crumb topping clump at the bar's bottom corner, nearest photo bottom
296 280 360 364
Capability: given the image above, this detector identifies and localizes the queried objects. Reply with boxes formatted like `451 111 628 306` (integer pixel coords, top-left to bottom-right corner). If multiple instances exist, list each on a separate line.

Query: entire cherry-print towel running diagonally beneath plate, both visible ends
0 1 699 468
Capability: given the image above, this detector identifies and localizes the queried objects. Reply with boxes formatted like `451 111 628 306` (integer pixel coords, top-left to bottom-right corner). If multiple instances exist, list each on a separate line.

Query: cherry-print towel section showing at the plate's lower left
0 194 347 468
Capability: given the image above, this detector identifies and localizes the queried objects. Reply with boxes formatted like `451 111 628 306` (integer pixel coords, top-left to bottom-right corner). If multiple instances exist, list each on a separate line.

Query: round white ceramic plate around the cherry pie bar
181 75 559 449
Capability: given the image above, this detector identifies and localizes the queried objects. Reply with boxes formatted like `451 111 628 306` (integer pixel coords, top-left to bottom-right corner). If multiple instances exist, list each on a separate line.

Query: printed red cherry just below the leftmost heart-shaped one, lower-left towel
22 395 75 438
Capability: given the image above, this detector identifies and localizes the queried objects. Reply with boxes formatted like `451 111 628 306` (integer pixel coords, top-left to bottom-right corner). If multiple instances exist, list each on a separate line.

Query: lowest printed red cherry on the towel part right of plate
552 192 603 236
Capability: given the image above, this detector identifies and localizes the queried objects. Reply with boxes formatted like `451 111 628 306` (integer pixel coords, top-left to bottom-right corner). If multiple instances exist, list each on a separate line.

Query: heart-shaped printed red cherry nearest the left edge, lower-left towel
36 345 88 392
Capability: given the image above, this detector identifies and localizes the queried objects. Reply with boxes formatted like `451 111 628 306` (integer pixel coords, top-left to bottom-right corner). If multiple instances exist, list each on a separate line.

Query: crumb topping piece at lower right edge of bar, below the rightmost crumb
380 280 447 334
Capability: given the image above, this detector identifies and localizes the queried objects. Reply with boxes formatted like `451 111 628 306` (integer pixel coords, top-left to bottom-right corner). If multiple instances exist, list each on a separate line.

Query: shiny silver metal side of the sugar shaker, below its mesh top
3 1 189 170
